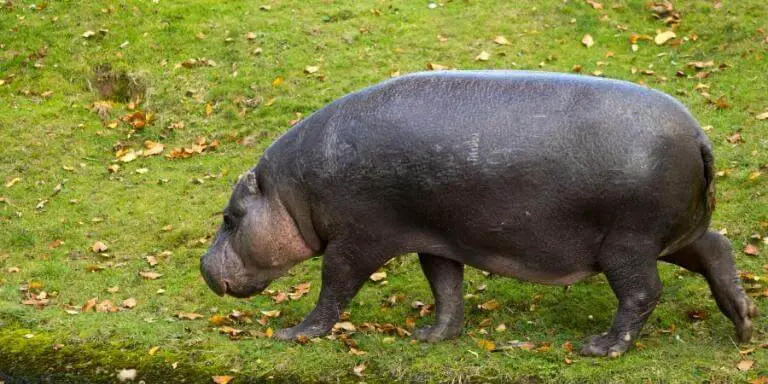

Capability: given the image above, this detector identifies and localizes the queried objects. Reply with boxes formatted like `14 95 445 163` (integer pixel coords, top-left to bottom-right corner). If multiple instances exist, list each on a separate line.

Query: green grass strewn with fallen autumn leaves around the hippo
0 0 768 383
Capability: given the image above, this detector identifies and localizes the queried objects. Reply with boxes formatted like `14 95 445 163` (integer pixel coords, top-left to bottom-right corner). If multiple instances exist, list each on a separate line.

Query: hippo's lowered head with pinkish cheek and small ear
200 171 314 298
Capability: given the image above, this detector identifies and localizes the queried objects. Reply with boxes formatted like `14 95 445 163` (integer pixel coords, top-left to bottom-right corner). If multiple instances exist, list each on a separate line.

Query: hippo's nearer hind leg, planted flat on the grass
581 234 662 357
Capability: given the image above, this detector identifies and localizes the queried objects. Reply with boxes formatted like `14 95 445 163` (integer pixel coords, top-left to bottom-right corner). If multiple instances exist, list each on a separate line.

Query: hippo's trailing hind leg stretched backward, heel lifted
661 232 758 343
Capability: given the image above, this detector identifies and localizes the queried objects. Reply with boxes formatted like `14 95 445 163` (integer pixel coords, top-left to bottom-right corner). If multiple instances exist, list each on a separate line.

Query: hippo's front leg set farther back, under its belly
414 253 464 343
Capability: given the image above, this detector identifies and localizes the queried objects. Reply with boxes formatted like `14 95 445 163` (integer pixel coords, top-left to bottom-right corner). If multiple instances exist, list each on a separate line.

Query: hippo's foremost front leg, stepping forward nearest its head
275 245 383 340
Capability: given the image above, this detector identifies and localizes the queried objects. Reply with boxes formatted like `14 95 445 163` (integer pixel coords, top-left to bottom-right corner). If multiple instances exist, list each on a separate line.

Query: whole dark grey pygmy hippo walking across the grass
202 71 757 356
